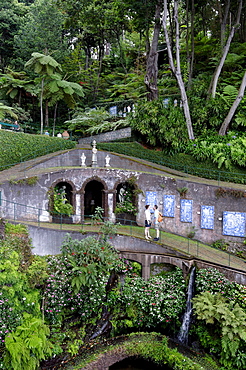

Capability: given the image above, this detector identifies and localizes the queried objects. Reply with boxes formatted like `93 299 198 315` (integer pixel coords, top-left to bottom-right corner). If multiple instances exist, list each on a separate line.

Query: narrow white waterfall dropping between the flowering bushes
178 266 196 345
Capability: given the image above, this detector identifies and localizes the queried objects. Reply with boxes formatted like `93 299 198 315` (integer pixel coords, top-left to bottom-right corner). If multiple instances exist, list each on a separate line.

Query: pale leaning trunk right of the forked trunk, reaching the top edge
208 0 243 98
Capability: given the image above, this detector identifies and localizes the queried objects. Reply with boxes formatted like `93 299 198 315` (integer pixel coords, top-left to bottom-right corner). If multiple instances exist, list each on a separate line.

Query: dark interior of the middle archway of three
84 180 105 217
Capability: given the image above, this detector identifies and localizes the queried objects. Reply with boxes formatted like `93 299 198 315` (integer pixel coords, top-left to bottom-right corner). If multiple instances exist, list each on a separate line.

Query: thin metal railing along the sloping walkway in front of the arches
0 199 246 271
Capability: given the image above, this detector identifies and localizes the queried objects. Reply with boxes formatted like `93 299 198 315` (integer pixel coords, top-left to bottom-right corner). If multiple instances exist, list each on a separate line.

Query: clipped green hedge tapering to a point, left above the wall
0 130 75 170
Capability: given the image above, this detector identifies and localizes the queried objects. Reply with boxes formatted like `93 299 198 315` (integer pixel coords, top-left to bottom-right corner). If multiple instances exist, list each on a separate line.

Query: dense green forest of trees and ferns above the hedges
0 0 246 143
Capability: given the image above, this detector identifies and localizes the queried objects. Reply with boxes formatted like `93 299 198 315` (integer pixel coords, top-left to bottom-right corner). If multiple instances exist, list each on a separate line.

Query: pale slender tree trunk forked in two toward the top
163 0 194 140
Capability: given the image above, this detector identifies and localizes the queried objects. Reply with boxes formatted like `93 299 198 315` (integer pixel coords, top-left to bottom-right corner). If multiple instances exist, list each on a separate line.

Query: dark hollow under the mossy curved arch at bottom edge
109 357 172 370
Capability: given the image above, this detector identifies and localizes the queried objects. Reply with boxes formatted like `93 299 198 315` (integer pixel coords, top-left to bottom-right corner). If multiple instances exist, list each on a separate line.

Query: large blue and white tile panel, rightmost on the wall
223 212 246 237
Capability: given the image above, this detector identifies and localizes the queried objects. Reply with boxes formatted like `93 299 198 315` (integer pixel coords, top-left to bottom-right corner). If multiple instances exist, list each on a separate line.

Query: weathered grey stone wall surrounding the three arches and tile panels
0 149 246 244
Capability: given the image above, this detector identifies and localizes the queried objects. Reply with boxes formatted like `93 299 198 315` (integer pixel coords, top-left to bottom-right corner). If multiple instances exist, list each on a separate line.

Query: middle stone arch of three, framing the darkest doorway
79 176 108 220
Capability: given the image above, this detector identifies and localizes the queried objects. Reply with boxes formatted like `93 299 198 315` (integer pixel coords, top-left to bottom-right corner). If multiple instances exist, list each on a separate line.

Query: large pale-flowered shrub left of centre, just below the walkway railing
44 233 124 323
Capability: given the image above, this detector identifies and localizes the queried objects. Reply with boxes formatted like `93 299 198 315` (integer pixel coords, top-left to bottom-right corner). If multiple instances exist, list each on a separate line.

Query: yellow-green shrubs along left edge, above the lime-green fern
0 233 40 354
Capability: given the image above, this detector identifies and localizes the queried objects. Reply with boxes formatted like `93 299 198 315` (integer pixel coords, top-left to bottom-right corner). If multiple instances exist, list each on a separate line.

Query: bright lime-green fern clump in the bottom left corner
4 313 52 370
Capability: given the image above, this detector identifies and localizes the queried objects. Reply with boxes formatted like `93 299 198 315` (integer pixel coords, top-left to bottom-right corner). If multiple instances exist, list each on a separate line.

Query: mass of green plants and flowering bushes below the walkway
0 222 246 370
